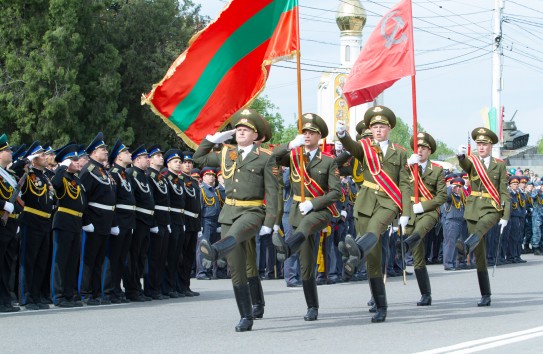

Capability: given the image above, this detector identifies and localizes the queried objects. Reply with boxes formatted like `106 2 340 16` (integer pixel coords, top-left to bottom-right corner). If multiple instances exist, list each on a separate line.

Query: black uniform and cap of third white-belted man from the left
123 145 155 302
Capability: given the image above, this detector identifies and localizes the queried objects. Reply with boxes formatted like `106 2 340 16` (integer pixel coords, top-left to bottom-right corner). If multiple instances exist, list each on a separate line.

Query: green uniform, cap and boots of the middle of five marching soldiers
340 106 411 322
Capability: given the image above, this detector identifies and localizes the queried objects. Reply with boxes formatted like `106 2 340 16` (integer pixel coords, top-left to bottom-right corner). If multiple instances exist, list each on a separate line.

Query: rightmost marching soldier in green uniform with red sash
457 128 510 306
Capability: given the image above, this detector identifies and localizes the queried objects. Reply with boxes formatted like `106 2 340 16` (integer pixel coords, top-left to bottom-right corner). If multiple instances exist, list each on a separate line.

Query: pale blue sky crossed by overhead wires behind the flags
195 0 543 148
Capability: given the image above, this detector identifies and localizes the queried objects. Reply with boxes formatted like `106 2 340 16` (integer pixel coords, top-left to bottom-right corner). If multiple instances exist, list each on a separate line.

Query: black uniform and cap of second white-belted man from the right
162 149 185 298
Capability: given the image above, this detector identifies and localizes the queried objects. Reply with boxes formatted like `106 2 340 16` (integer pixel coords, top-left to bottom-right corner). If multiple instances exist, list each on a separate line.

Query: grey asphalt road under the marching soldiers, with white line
0 255 543 353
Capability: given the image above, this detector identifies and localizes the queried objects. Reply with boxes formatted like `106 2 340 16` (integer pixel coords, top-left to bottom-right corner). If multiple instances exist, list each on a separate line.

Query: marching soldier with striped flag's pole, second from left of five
272 113 341 321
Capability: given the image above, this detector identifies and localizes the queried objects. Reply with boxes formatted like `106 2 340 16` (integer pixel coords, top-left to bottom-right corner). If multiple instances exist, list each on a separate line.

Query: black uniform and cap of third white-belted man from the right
144 145 171 300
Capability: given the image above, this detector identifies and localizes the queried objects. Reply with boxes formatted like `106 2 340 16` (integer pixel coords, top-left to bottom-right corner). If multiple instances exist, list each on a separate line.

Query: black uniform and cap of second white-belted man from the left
104 140 136 303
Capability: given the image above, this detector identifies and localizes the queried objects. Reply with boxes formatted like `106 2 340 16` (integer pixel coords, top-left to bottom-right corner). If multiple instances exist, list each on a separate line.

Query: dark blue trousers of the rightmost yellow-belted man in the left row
51 230 81 304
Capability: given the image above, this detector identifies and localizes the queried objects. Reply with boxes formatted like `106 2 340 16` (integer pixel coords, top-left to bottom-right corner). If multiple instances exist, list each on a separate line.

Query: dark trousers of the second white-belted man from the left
102 227 132 298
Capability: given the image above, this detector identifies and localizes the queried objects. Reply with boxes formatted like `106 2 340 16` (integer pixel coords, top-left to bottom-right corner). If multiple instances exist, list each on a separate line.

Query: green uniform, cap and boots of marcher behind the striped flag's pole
272 113 342 320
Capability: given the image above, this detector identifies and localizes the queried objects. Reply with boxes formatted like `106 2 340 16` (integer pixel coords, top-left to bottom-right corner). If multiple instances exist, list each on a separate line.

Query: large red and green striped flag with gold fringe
143 0 299 148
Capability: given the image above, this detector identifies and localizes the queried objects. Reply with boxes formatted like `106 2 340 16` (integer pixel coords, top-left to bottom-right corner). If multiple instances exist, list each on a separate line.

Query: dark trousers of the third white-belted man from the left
123 223 151 297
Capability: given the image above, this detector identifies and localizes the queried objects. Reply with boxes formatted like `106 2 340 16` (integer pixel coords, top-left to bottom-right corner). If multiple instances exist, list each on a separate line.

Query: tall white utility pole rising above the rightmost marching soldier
492 0 505 158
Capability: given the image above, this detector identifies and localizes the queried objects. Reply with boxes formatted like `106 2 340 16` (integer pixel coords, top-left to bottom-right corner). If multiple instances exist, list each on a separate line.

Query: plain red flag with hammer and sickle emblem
343 0 415 107
